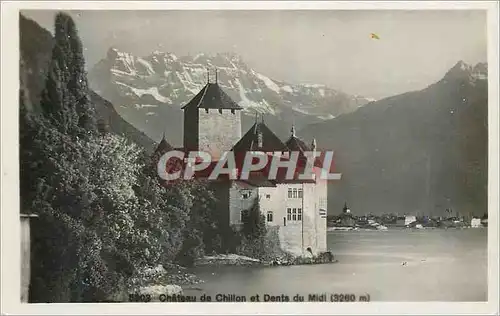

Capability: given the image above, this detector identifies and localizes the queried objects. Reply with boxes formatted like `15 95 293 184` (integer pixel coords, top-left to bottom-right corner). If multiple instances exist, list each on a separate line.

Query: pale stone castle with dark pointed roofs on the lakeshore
155 75 338 255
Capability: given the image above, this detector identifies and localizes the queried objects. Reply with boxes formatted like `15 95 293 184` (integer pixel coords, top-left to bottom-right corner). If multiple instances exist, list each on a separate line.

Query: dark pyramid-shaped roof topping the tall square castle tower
182 82 242 110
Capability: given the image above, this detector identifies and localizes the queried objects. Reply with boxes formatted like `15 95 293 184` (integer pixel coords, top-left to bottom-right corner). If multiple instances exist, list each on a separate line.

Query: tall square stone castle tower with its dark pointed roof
182 72 242 160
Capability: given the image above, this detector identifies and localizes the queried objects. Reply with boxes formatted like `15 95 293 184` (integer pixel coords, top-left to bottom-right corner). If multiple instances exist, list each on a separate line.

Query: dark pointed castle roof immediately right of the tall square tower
232 122 288 152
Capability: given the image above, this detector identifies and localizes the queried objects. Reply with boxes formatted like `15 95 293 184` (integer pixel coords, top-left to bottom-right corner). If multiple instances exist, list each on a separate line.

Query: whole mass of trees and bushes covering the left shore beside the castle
19 9 274 302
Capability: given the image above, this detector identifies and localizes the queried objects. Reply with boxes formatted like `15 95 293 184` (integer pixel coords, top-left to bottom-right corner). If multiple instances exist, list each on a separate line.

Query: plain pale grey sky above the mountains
21 10 487 99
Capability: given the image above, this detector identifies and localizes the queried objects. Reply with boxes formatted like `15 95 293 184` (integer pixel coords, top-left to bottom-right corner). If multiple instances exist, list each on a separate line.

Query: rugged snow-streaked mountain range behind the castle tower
89 48 371 144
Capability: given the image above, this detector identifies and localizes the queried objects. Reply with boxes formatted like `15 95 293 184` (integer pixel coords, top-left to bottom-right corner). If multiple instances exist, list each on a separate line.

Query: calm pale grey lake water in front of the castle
185 229 488 301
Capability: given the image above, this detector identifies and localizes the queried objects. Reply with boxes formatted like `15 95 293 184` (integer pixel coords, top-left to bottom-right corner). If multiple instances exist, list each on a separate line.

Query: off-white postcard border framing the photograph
0 1 499 315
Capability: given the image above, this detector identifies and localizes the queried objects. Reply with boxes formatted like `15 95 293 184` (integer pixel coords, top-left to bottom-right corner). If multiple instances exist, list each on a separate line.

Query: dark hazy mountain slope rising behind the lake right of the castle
298 61 488 216
